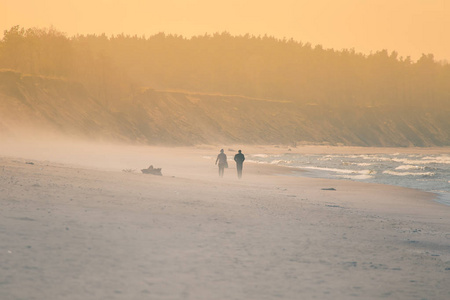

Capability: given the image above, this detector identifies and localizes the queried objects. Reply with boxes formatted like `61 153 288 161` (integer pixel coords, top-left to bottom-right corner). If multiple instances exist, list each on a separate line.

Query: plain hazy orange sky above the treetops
0 0 450 61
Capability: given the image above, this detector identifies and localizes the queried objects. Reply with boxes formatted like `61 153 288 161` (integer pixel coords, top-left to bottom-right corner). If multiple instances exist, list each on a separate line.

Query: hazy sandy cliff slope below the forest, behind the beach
0 71 450 146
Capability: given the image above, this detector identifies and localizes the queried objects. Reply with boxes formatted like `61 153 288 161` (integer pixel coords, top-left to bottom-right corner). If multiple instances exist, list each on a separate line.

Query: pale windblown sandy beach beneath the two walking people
0 145 450 300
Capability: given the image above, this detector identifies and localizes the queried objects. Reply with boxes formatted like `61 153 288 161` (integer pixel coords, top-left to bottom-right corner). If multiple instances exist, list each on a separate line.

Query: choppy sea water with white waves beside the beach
248 153 450 205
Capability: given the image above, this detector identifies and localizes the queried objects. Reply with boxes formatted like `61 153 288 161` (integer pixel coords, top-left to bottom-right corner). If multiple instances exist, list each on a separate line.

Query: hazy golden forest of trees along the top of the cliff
0 26 450 109
